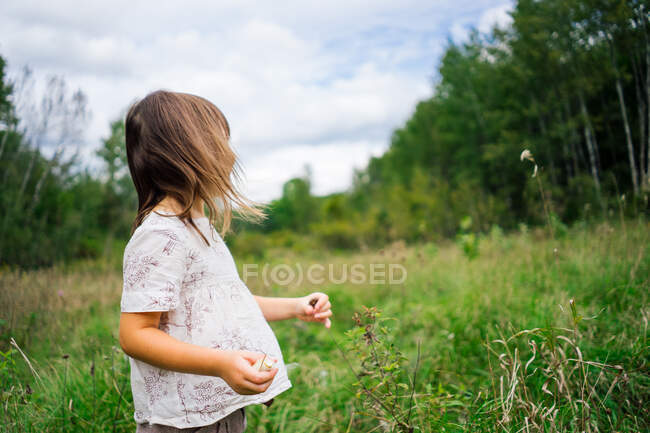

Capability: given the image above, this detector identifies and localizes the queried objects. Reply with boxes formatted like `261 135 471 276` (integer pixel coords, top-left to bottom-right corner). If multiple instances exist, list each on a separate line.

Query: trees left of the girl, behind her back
0 62 137 267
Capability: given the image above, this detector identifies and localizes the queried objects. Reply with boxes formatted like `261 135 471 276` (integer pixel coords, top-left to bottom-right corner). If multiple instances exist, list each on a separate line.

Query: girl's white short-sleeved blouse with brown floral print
121 208 291 428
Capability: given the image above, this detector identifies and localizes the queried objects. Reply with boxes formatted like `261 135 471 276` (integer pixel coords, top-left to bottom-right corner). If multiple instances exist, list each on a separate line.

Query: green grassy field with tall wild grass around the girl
0 220 650 432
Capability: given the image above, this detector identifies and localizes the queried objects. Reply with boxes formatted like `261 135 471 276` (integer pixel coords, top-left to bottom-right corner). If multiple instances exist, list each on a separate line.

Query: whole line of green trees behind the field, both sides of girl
0 0 650 266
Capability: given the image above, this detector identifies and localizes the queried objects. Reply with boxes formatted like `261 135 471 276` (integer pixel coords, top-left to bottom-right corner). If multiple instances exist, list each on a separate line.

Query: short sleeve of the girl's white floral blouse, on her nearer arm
121 226 186 313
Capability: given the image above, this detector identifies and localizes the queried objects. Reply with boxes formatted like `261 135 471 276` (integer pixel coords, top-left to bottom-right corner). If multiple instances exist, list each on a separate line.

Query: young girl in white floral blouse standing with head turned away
119 91 332 433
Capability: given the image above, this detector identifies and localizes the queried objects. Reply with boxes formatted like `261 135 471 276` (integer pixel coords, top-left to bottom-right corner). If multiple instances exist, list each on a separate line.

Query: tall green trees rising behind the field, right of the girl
242 0 650 253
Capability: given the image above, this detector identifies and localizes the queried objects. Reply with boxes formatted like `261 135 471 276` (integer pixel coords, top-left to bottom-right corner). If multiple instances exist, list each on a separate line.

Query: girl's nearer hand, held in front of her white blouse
217 350 278 395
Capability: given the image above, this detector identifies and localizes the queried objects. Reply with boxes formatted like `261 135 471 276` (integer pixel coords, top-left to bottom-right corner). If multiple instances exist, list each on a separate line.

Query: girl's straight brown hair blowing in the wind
125 90 262 244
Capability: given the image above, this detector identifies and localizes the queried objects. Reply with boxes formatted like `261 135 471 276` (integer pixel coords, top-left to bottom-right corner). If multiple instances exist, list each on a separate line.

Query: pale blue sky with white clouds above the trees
0 0 512 202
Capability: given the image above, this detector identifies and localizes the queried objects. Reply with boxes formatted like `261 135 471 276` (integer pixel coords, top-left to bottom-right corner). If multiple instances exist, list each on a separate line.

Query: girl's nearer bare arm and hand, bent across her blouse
119 312 278 394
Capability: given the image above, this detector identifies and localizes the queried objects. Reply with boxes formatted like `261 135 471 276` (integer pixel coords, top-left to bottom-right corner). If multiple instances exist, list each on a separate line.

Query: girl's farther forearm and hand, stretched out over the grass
255 292 332 328
